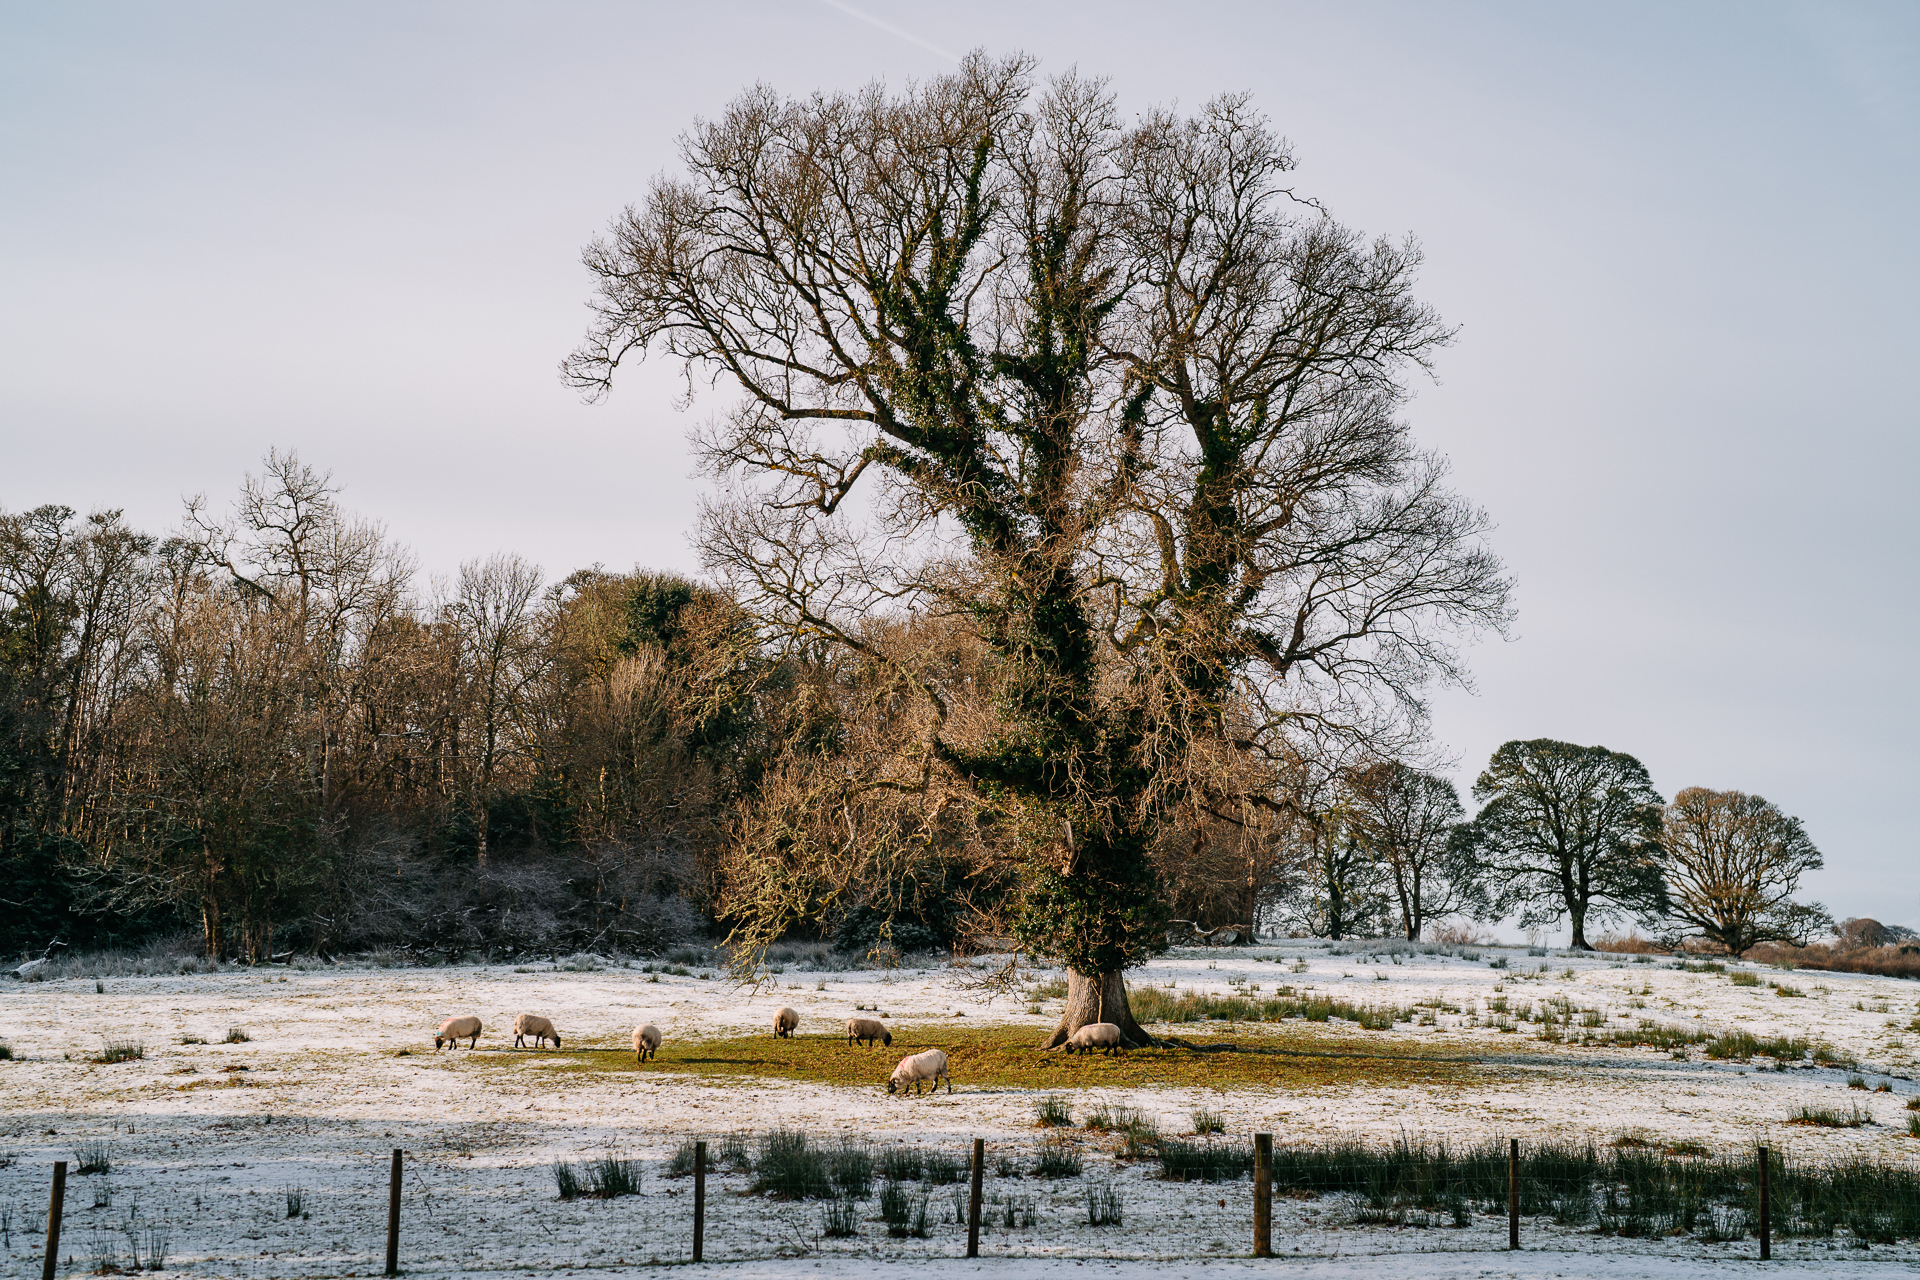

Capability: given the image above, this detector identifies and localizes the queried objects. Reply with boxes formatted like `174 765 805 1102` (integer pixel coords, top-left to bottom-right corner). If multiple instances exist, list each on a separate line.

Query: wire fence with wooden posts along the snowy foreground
15 1111 1920 1276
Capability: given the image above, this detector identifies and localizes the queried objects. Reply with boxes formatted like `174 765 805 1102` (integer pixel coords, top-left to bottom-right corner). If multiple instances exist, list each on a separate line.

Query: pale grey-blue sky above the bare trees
0 0 1920 925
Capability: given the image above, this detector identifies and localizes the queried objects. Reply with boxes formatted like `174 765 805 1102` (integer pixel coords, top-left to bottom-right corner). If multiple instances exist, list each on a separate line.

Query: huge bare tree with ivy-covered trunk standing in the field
566 54 1507 1044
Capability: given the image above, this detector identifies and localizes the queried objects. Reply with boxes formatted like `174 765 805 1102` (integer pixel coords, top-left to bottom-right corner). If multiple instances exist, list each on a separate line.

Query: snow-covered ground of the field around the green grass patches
0 942 1920 1278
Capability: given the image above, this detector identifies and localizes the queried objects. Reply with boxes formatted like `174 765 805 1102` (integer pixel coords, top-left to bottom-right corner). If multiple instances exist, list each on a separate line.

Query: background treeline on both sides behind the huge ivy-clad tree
0 455 1830 960
